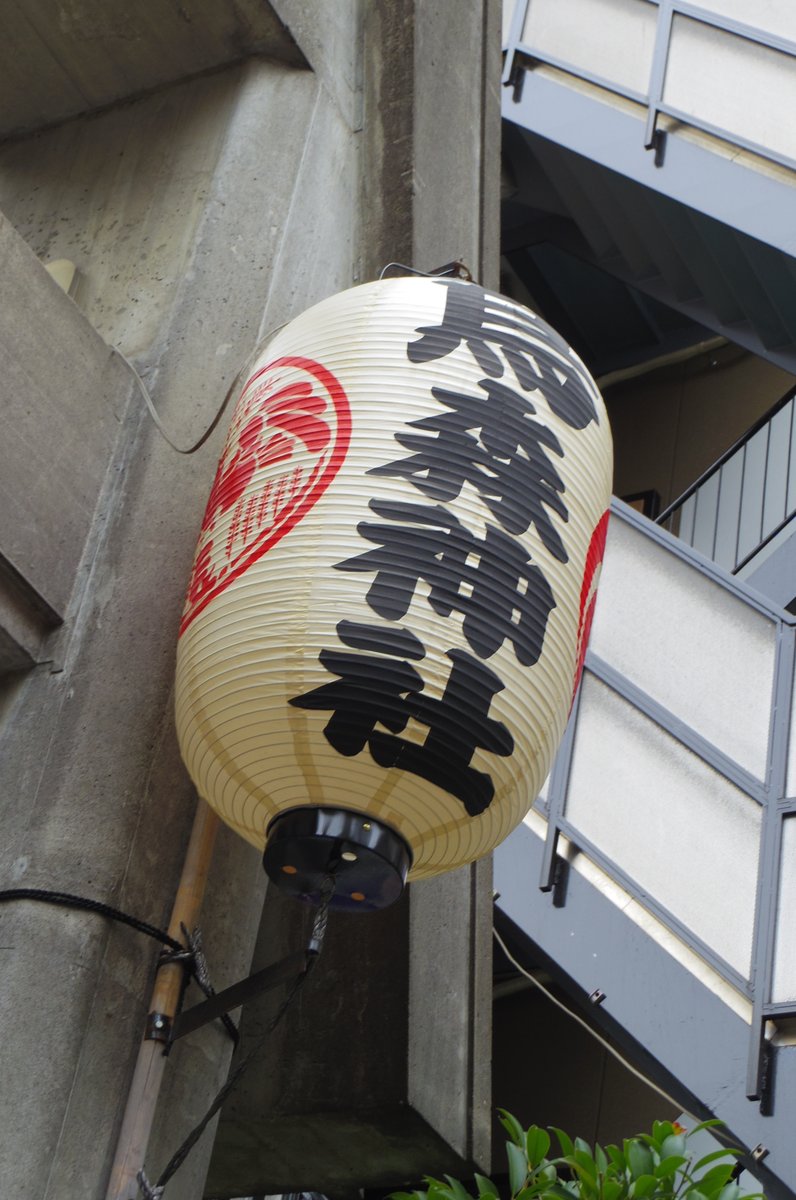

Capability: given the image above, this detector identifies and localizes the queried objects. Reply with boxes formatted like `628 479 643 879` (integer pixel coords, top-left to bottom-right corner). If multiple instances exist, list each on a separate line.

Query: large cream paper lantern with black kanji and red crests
176 278 611 910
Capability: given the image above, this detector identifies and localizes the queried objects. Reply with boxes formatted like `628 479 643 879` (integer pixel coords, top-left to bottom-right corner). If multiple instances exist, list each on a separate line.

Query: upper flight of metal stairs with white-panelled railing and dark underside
503 0 796 371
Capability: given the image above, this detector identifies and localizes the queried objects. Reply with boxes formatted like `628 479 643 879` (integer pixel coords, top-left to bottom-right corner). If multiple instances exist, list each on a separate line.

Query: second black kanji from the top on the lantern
369 379 569 563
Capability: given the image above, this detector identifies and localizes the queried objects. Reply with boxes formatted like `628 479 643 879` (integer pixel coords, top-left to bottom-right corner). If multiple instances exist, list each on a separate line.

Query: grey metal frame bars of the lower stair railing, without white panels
539 500 796 1111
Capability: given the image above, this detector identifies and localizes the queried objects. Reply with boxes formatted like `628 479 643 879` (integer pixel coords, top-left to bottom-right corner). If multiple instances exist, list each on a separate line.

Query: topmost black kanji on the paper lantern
407 280 599 430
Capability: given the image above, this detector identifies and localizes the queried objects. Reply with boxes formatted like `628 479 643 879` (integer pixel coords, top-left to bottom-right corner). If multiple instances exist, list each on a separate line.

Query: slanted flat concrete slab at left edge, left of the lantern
0 207 130 643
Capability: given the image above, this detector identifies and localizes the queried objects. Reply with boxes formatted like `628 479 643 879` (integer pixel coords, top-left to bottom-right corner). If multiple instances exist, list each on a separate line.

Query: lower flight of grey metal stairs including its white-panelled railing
495 502 796 1200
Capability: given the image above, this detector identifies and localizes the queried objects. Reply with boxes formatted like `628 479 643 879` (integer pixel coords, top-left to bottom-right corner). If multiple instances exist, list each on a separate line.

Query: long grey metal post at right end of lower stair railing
747 624 796 1106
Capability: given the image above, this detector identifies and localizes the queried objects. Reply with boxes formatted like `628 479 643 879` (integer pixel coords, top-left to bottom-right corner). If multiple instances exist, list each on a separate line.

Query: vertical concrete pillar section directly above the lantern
363 0 501 287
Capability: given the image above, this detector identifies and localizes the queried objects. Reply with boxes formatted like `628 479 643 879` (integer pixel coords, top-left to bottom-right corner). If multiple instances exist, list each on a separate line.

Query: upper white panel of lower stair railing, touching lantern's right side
591 517 776 779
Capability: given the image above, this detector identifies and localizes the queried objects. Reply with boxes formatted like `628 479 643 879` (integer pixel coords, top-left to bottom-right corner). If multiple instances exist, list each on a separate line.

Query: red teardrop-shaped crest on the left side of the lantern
180 356 351 634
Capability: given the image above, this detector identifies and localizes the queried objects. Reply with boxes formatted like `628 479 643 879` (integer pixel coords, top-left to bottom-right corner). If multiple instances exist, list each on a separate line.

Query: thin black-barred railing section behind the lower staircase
657 389 796 574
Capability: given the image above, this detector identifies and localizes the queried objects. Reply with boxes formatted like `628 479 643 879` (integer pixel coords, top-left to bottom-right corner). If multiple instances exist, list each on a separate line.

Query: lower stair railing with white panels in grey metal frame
521 502 796 1098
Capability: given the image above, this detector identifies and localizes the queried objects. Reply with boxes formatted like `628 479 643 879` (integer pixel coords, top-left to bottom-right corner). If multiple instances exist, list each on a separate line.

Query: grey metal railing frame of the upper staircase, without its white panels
503 0 796 169
